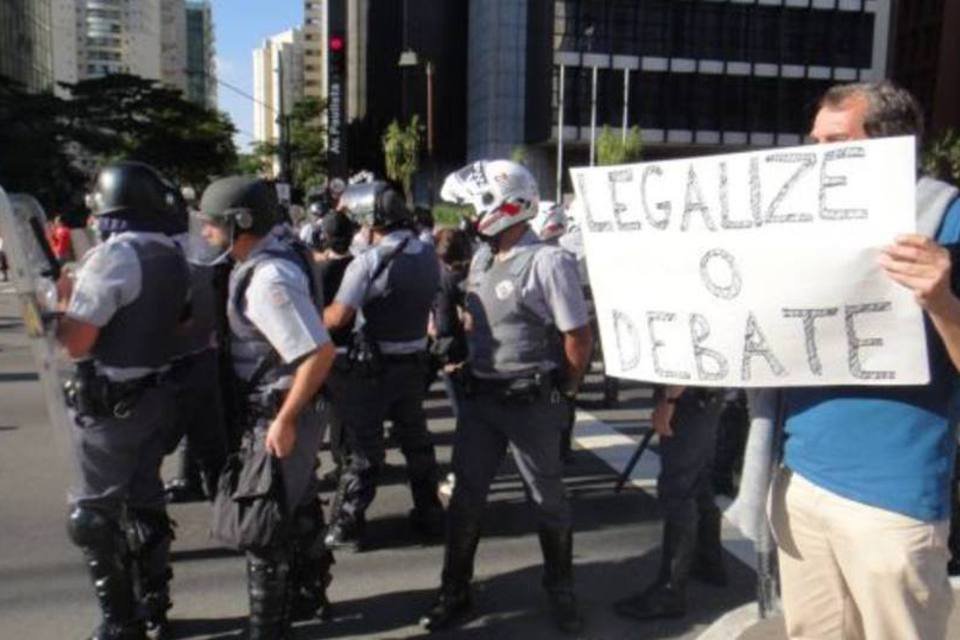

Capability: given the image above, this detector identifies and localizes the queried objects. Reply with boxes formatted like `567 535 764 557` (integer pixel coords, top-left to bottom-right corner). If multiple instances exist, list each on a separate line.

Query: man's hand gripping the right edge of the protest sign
878 234 956 315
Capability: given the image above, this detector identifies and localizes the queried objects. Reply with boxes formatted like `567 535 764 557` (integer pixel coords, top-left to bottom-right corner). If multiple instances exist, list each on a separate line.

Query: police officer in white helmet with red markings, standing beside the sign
420 160 593 633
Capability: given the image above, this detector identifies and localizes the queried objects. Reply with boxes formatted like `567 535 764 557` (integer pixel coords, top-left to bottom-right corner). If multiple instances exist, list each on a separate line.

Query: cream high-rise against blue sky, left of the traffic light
253 29 304 149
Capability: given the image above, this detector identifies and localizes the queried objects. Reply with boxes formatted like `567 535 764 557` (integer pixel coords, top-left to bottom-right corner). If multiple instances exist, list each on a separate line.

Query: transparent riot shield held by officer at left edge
0 188 70 443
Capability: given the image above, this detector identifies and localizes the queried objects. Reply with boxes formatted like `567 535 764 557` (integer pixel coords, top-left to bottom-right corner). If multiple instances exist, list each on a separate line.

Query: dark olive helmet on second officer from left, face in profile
200 176 280 236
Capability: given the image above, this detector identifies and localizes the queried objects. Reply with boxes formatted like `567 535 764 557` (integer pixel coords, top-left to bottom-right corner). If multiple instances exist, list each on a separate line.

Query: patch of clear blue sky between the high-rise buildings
211 0 303 151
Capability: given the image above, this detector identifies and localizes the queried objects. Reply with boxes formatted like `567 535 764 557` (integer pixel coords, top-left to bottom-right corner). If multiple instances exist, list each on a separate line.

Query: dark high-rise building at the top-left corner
0 0 53 91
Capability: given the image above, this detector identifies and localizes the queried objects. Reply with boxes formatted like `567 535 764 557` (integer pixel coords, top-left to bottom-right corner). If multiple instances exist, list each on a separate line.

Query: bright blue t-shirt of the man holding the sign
784 200 960 522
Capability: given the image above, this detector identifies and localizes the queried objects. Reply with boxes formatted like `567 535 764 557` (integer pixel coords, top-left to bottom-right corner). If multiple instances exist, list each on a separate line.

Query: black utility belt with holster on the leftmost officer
63 361 161 420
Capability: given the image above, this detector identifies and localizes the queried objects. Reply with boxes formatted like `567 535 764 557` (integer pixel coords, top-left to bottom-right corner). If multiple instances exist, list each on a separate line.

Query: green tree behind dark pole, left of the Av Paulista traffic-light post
254 98 327 192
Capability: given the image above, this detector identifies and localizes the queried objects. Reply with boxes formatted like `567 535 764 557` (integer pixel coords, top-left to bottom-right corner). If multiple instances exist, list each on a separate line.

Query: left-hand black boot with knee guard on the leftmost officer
67 507 146 640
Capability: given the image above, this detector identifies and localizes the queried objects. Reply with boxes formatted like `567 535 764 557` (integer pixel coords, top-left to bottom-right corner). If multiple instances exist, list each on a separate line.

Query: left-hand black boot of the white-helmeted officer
420 514 480 631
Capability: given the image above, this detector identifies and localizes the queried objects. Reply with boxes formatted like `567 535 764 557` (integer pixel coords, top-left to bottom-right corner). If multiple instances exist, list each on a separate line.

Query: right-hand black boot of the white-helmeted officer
538 527 583 633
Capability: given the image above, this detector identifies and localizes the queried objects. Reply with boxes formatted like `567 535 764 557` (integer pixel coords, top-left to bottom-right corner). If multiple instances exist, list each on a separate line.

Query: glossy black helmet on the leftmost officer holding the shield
90 161 185 218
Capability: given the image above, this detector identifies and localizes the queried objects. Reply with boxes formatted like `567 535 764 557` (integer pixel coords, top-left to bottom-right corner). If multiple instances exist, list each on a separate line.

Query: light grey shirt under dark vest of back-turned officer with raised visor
334 229 427 355
